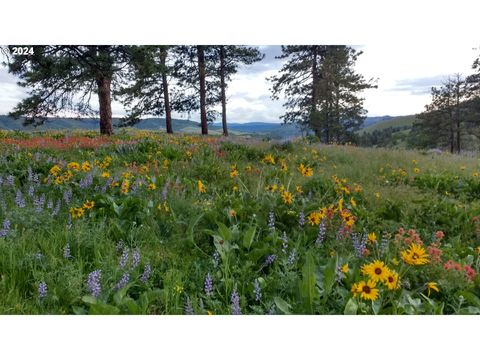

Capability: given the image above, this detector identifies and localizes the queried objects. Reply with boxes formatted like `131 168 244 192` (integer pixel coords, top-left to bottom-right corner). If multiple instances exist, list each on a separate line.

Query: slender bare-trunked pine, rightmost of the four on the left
213 45 264 136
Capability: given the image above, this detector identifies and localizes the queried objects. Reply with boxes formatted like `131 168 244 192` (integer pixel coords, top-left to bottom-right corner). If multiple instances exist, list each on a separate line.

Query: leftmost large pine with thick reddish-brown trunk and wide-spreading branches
8 46 127 135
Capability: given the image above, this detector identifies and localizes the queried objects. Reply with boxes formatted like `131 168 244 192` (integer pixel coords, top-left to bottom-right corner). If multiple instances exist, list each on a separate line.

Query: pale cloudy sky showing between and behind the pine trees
0 43 480 123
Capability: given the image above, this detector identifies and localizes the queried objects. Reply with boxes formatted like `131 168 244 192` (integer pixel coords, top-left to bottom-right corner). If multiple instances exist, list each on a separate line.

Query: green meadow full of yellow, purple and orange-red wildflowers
0 131 480 315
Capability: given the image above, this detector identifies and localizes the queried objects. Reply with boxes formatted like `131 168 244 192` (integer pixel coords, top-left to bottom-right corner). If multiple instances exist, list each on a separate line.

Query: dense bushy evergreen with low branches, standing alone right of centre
269 45 375 143
